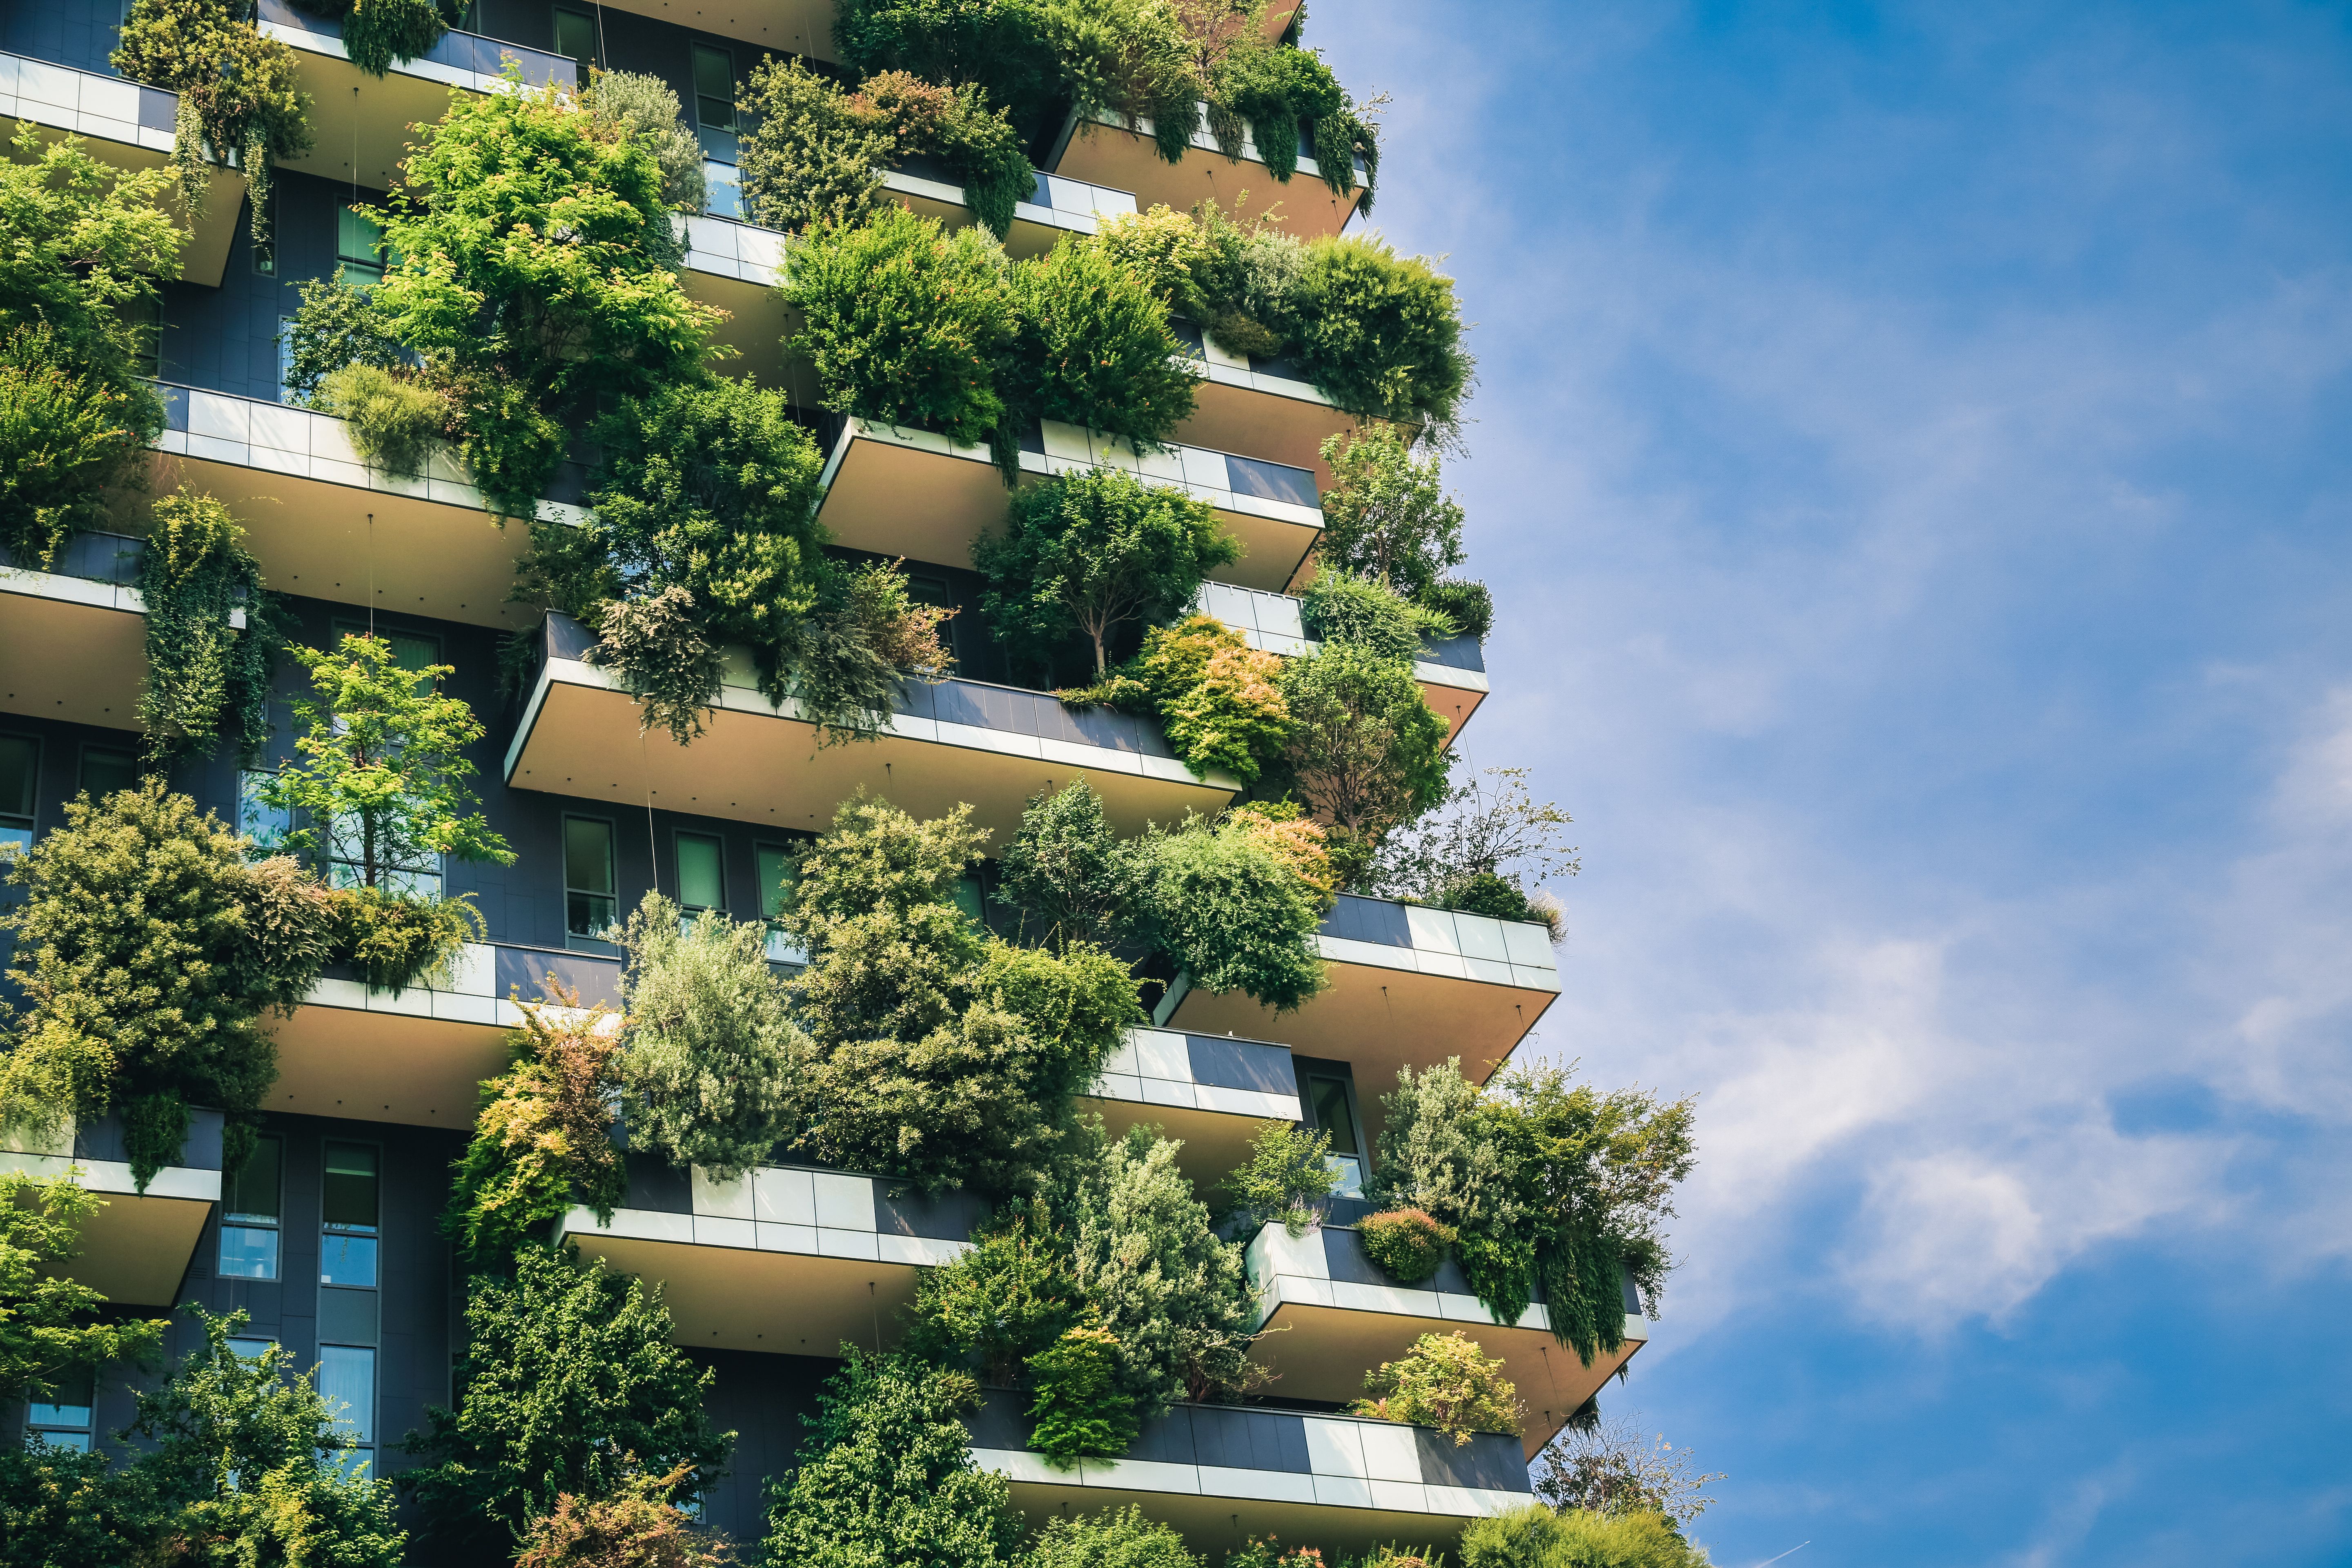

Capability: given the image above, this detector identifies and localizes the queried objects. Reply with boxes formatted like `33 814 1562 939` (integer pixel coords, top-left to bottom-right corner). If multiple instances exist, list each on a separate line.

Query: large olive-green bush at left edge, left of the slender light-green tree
0 780 332 1189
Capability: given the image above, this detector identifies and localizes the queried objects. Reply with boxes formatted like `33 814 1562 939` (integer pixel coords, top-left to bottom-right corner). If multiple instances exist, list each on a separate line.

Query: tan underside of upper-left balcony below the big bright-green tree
153 442 539 628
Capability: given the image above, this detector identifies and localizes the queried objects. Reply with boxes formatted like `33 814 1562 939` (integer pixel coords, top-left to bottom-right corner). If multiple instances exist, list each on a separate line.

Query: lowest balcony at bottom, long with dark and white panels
964 1392 1534 1561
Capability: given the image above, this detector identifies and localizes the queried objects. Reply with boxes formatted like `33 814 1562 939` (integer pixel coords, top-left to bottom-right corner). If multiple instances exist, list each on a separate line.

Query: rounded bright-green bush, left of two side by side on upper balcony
779 205 1014 444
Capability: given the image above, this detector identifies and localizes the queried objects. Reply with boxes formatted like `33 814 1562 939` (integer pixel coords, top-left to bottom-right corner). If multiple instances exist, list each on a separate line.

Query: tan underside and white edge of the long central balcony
506 658 1237 844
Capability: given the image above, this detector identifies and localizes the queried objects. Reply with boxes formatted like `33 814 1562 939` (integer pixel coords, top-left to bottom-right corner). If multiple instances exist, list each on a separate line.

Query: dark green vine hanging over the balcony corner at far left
139 487 280 769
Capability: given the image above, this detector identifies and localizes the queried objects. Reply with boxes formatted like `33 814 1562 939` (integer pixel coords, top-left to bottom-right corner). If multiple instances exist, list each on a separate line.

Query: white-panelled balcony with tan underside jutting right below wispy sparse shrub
1152 893 1559 1098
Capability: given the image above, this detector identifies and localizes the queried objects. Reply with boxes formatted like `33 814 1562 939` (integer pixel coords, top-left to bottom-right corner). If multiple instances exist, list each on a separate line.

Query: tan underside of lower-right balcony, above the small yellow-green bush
1251 1286 1649 1457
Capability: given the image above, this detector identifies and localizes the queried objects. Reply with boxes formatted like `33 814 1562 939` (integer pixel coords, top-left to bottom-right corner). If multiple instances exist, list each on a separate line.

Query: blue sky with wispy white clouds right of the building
1308 0 2352 1568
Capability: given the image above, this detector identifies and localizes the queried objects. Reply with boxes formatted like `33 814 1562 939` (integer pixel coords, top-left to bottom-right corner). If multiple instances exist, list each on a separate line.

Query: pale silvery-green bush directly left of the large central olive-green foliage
621 893 809 1180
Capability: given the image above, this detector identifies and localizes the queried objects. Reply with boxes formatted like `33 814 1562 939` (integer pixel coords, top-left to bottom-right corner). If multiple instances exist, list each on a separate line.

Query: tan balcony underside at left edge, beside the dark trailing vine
0 566 146 729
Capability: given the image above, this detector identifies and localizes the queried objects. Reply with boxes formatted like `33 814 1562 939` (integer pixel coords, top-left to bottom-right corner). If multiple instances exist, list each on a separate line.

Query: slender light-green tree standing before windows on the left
261 633 515 891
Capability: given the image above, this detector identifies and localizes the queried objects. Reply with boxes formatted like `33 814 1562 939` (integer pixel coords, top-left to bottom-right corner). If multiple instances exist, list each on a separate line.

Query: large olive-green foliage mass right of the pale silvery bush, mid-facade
783 795 1141 1194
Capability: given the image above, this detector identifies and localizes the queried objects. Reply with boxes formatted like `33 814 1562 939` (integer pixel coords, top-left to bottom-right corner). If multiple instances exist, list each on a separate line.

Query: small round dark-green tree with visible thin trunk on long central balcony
971 468 1242 679
